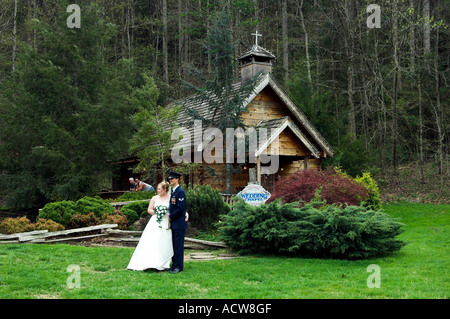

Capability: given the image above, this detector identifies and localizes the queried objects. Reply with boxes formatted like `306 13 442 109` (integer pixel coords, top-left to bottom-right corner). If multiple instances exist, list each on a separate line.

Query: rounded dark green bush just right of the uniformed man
186 185 230 230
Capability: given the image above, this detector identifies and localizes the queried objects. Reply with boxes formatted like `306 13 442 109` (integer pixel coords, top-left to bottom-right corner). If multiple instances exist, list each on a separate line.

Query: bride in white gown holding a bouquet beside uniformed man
127 182 173 271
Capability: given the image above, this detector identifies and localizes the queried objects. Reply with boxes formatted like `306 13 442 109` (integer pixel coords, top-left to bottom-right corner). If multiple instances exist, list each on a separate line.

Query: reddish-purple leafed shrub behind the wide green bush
267 169 369 206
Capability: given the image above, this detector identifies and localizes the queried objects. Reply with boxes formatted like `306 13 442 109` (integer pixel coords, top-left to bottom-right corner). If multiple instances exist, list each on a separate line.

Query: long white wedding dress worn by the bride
127 201 173 271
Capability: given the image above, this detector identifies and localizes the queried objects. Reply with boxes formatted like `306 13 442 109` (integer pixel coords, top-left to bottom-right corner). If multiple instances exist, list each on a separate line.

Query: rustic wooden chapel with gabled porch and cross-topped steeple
166 37 334 194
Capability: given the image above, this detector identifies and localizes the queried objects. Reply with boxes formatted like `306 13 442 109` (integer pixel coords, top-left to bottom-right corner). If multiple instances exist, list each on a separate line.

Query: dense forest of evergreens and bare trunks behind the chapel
0 0 450 208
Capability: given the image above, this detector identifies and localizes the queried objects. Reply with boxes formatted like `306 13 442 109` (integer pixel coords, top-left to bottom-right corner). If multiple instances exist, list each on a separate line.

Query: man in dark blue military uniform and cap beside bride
168 172 187 274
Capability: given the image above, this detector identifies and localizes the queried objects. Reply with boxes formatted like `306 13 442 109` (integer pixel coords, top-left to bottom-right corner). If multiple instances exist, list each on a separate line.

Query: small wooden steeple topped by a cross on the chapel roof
238 31 275 84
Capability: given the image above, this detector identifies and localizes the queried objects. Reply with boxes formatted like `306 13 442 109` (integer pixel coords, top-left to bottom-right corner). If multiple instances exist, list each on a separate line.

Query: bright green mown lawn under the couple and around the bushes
0 203 450 299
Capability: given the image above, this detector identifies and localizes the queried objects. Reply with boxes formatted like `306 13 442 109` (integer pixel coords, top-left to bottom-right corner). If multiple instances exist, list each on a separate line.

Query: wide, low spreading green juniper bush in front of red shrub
219 200 405 259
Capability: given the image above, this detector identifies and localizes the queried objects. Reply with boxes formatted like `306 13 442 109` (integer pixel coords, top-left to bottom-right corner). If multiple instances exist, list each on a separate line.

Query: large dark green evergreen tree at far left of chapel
0 5 136 208
